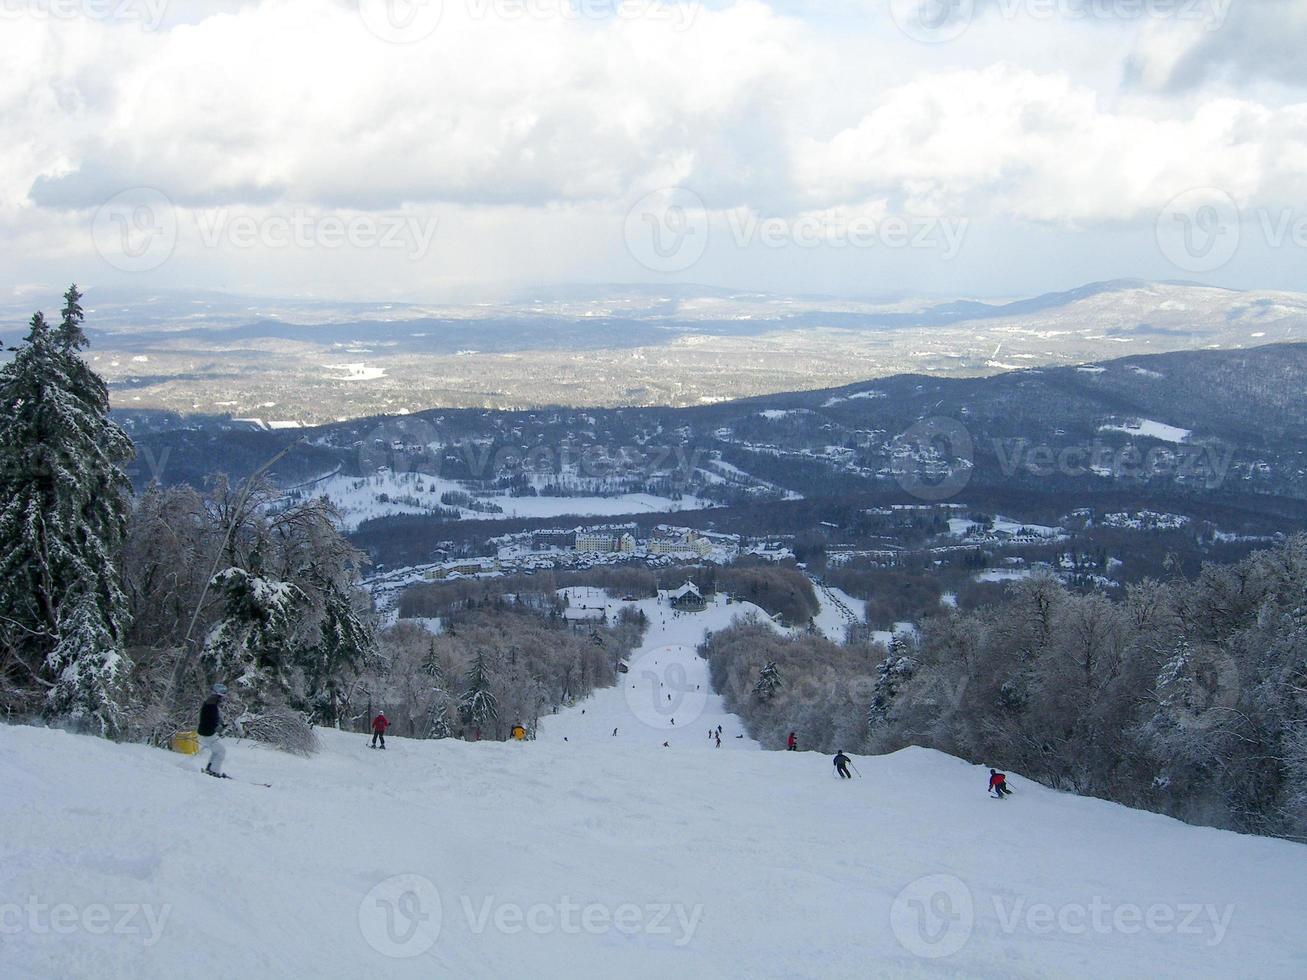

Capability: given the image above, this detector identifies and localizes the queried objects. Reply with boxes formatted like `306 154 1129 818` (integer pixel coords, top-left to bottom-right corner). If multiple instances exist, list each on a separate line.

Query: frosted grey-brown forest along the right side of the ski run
701 536 1307 840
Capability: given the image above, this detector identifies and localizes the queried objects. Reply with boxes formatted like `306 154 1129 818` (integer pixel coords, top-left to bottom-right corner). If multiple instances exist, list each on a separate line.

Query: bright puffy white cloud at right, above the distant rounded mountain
796 64 1307 226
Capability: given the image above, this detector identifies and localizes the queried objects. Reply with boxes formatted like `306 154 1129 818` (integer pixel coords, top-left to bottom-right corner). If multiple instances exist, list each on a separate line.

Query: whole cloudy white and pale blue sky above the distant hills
0 0 1307 301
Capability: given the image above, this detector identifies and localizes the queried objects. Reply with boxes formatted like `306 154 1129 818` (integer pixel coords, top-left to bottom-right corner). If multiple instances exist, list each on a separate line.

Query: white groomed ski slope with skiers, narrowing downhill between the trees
0 595 1307 980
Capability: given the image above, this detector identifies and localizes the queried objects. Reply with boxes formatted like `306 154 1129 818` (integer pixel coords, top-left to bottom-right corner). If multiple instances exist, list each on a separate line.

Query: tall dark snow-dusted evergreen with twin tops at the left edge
0 301 133 734
